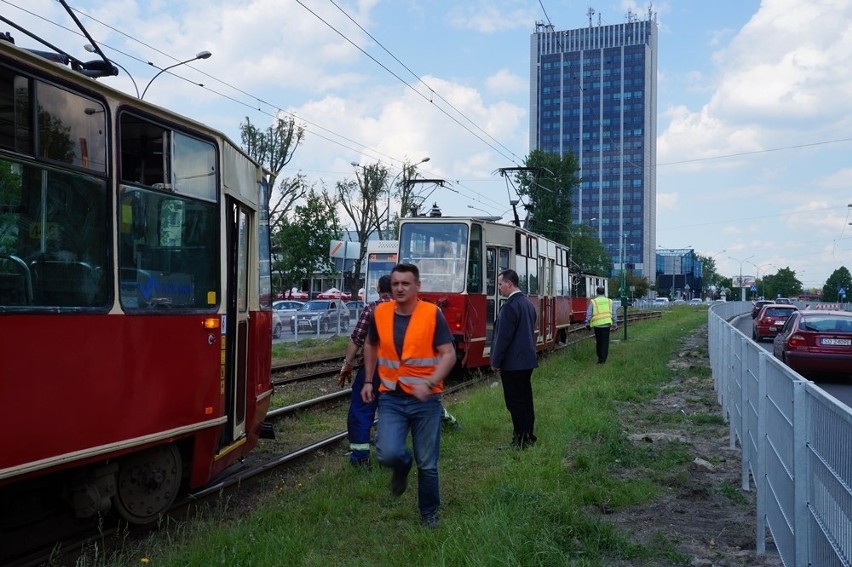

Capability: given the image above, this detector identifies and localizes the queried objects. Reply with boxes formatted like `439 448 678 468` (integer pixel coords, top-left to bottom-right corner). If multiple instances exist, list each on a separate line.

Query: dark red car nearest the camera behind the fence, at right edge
772 310 852 377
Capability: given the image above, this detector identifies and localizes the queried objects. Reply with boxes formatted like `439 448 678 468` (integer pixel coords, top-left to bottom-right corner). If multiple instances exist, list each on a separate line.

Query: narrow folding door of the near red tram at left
222 197 252 445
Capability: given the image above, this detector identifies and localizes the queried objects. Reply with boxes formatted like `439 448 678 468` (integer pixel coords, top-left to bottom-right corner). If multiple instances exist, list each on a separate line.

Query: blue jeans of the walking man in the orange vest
376 393 443 517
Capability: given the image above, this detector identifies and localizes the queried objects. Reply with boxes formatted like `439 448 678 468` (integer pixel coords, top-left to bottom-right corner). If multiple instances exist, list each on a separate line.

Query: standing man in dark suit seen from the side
491 270 538 449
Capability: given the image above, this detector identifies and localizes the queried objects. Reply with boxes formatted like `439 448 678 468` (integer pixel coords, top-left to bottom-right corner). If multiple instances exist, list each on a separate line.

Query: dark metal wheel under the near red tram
113 445 183 524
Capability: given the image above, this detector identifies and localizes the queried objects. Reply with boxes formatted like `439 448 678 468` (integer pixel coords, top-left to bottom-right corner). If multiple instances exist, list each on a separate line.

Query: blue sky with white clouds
6 0 852 286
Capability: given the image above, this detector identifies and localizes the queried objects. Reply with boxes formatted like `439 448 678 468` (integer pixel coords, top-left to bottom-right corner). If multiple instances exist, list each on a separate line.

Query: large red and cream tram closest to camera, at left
0 40 272 523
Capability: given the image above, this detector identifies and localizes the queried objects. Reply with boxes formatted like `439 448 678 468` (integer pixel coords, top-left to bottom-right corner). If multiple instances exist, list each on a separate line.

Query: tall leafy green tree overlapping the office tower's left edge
515 150 580 237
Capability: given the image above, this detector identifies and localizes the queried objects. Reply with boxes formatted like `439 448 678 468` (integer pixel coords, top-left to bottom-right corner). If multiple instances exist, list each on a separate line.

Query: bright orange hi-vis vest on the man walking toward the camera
373 300 444 394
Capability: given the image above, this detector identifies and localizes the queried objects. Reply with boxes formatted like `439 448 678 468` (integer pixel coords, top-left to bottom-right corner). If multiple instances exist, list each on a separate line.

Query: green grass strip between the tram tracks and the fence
76 310 712 567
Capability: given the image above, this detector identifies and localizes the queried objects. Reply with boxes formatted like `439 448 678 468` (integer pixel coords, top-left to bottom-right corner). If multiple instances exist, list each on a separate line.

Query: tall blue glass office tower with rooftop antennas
530 10 657 281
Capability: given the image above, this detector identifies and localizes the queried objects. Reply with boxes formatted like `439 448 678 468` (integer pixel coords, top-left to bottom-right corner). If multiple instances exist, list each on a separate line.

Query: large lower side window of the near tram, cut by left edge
0 159 111 308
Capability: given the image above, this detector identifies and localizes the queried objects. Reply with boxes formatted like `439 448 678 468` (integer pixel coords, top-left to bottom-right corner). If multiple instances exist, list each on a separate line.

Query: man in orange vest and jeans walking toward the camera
361 264 456 528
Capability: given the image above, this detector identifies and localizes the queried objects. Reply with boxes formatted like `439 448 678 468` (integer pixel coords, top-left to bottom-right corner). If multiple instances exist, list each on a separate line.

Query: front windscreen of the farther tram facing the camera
400 223 469 293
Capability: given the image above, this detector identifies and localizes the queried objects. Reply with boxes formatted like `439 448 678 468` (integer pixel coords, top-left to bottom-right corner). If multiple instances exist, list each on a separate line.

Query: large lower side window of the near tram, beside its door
118 186 220 311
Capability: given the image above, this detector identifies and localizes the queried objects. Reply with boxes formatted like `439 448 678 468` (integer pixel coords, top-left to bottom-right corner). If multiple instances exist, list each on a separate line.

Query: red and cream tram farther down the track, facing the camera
398 217 607 368
